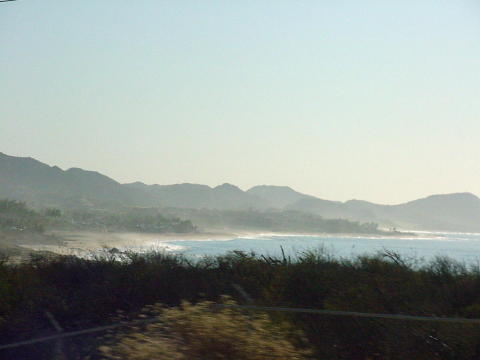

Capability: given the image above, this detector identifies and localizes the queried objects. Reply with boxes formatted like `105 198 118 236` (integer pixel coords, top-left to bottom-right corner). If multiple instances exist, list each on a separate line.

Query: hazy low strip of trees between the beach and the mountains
0 200 385 234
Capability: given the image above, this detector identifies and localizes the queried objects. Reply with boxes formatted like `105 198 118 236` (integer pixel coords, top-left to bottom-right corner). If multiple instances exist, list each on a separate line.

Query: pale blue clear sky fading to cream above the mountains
0 0 480 204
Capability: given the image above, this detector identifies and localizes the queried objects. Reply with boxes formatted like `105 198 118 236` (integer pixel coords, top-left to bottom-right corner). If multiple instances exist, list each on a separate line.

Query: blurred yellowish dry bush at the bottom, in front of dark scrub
100 299 310 360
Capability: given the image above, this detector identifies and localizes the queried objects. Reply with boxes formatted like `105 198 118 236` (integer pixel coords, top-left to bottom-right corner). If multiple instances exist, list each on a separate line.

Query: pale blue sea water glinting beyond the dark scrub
157 232 480 265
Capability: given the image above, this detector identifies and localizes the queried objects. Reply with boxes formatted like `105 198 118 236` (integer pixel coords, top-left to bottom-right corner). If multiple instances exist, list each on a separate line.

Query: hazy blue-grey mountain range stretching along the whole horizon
0 153 480 232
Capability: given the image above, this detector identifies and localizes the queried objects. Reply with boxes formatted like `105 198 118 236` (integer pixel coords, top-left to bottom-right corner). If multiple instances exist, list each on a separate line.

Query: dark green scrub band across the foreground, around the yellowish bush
0 252 480 360
